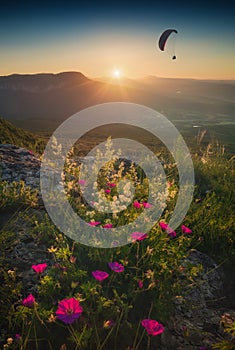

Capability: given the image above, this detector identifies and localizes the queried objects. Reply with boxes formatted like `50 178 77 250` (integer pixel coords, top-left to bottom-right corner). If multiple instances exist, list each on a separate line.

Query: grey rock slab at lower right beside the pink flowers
161 250 232 350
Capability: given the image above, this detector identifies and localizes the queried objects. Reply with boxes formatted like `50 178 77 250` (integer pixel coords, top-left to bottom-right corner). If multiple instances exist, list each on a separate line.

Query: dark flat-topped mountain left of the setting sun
0 72 109 131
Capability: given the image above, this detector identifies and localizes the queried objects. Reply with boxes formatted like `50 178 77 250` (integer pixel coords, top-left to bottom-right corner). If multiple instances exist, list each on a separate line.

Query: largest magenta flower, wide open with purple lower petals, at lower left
56 298 83 324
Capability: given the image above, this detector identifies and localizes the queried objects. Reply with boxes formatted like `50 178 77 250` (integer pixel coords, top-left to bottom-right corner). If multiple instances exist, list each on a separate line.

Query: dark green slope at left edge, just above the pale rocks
0 117 46 153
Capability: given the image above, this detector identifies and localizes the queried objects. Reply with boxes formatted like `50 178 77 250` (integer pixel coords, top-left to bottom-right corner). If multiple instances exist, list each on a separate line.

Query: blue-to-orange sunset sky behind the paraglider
0 0 235 79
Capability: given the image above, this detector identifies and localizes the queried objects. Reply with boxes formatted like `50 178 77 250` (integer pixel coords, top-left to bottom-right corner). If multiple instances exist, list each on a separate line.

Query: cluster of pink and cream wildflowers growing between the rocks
0 140 197 350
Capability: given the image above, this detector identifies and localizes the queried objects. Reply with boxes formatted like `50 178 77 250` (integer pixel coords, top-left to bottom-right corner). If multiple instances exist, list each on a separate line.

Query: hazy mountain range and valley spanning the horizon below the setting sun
0 72 235 152
